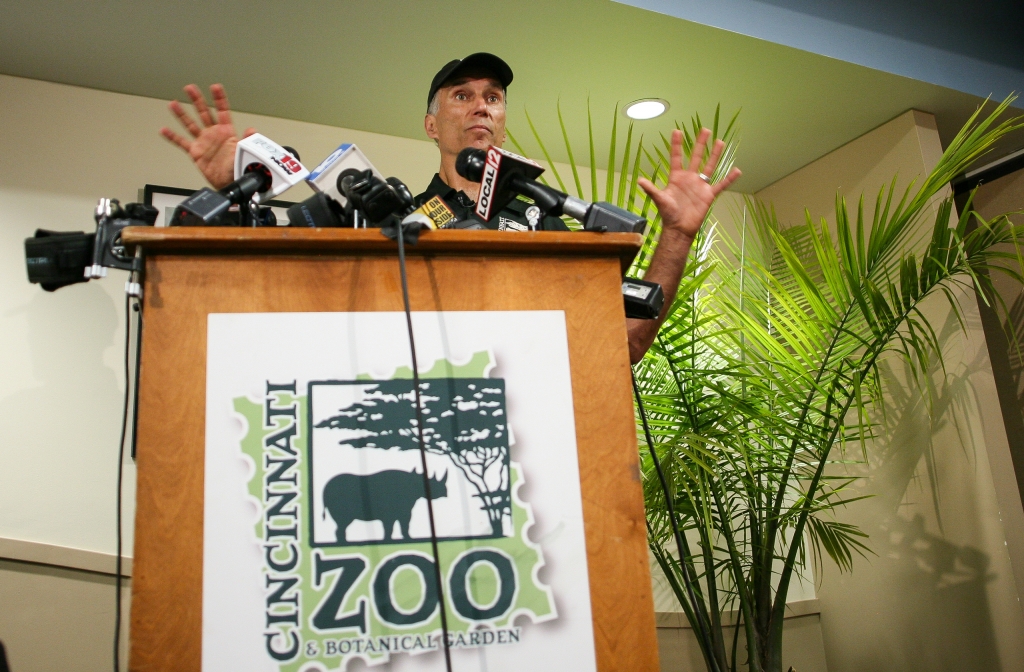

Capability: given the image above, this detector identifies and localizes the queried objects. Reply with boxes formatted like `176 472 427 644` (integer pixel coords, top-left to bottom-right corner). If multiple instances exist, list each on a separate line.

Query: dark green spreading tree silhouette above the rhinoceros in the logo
314 378 512 536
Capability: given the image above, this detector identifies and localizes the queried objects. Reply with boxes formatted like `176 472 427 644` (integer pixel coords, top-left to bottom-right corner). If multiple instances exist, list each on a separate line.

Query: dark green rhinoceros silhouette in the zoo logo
324 469 447 544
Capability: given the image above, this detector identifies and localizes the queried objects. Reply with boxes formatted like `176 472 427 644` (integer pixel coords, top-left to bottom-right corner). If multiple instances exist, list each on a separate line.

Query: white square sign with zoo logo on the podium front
203 311 596 672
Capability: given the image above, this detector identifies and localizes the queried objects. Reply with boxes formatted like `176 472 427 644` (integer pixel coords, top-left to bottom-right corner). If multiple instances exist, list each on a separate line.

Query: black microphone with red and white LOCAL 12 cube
455 146 647 234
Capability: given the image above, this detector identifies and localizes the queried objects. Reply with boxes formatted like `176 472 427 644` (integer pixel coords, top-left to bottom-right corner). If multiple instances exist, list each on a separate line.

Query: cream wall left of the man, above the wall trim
0 76 437 555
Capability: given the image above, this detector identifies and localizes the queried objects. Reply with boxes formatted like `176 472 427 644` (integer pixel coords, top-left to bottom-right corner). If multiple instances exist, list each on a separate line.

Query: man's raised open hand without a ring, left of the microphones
160 84 256 188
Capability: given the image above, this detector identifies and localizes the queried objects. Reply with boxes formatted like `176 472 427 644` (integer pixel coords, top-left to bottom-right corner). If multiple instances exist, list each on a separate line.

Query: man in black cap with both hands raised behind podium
160 53 740 364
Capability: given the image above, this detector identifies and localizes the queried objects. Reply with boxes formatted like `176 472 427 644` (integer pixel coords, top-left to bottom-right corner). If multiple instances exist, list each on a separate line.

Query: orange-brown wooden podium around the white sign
124 227 658 672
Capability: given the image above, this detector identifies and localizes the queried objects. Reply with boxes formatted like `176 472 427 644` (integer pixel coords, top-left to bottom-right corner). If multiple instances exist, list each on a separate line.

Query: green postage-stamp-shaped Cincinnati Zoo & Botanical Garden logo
234 352 557 672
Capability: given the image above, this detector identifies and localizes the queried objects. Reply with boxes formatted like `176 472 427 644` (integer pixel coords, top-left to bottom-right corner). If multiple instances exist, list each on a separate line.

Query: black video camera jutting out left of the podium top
25 199 158 292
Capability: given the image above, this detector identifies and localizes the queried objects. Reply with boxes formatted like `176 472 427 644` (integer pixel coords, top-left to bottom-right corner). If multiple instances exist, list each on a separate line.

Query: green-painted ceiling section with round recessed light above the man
0 0 1024 193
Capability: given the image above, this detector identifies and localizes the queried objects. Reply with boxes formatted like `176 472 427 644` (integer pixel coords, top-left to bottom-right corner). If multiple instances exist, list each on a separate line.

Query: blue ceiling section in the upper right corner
615 0 1024 99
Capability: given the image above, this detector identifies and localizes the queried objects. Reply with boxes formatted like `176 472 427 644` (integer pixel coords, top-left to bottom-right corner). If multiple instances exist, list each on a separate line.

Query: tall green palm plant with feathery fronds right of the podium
510 98 1024 672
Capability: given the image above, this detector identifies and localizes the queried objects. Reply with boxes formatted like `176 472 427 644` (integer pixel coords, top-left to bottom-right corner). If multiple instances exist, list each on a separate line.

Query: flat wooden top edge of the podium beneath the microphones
122 226 643 269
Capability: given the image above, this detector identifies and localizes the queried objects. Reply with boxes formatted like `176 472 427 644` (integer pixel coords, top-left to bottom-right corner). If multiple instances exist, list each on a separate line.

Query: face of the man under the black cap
423 73 505 154
